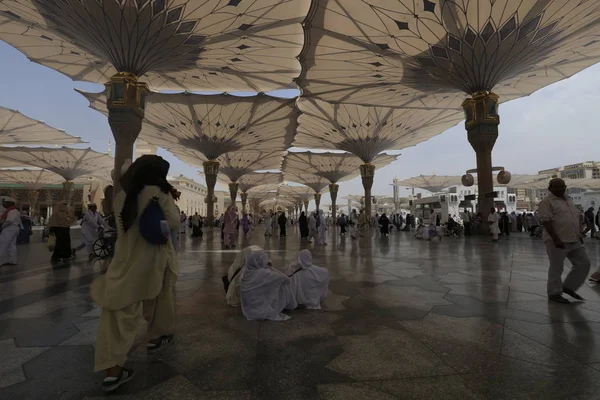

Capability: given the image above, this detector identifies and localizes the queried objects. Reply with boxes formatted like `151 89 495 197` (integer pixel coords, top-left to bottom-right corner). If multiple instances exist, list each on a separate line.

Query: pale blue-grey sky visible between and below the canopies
0 41 600 209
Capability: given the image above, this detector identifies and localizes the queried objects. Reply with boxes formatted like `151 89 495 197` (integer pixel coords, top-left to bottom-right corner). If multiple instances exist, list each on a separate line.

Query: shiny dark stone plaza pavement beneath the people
0 229 600 400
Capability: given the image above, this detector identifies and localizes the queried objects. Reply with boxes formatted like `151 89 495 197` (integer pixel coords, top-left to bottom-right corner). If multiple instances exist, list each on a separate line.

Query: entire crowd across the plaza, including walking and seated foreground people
5 159 600 391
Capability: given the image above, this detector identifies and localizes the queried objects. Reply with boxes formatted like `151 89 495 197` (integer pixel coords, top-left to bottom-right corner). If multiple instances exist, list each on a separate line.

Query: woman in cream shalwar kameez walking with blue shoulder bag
91 155 180 391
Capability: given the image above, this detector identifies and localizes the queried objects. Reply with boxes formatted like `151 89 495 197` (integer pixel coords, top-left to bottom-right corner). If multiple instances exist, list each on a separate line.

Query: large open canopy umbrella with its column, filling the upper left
0 0 312 192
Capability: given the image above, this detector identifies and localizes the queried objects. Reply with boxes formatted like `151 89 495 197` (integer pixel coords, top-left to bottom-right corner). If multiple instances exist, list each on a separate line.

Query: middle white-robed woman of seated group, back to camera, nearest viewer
240 251 298 321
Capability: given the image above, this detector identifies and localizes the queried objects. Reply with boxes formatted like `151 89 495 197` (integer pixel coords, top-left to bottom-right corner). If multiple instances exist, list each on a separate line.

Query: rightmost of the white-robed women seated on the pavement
288 249 329 310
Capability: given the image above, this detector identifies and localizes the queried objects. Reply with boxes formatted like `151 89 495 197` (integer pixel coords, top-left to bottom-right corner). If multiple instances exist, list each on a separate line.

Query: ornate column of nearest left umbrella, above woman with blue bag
105 72 148 196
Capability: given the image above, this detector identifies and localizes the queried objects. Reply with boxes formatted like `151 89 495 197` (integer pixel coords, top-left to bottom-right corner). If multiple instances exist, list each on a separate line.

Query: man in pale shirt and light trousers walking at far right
538 178 590 303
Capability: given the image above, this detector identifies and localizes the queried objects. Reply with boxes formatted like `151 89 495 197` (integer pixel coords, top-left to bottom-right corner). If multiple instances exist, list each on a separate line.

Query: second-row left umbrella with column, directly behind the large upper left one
82 89 298 224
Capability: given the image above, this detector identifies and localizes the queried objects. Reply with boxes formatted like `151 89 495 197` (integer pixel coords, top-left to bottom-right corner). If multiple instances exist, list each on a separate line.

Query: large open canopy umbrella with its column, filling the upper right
297 0 600 218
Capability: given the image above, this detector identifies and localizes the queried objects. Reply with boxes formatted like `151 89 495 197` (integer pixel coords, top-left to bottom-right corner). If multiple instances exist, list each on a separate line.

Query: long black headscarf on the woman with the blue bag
119 155 173 232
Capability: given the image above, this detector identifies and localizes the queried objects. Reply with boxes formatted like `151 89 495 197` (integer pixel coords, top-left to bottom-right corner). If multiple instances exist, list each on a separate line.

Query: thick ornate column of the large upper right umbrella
462 91 500 222
